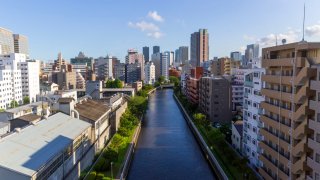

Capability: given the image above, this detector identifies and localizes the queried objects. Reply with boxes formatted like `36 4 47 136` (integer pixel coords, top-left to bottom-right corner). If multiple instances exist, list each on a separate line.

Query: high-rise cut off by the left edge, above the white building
0 27 14 54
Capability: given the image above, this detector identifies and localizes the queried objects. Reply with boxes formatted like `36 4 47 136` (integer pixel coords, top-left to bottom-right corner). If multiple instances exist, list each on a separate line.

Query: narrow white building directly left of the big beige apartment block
242 68 265 167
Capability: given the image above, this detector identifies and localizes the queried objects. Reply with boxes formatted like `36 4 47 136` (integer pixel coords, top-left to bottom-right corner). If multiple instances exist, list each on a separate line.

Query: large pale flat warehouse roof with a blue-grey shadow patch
0 113 91 176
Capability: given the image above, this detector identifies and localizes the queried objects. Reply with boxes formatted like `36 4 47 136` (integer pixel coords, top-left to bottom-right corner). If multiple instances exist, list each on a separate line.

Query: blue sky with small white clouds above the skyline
0 0 320 60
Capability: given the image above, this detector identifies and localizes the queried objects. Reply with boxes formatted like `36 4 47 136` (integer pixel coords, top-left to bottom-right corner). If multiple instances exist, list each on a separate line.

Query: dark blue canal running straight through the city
128 89 216 180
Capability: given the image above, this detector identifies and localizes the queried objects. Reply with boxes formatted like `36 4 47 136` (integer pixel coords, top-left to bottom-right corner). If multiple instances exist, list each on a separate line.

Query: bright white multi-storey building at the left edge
0 53 40 109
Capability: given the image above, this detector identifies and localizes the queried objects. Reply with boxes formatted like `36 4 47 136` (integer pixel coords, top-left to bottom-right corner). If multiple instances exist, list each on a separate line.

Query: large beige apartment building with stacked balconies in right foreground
259 41 320 179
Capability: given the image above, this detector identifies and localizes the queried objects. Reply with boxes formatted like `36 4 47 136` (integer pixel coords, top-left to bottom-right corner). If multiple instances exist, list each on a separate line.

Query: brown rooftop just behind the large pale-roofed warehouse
74 99 110 121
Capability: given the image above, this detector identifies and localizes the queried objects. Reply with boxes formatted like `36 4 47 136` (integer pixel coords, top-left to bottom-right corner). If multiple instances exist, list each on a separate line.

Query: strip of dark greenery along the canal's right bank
175 89 257 179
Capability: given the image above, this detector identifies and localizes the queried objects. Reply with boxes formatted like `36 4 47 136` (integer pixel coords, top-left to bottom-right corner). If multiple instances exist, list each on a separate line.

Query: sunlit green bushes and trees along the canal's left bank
80 93 148 180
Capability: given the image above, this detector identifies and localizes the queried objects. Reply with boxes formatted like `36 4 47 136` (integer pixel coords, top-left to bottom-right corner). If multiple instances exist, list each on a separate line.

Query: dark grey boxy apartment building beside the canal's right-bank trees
199 76 232 124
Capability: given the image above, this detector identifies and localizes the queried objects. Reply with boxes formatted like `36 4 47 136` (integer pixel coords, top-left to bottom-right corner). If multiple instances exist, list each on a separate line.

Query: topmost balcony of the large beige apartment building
262 57 307 67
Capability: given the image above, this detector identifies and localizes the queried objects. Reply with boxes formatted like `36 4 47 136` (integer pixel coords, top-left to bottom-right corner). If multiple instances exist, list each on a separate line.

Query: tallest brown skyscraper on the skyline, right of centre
190 29 209 66
